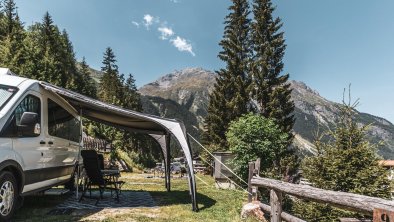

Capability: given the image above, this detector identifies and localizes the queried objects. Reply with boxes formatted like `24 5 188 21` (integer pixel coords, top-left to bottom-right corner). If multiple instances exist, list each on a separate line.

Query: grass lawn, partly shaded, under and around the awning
14 173 255 222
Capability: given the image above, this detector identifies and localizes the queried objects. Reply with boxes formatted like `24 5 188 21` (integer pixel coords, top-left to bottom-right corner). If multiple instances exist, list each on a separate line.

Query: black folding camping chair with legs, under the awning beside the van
79 150 124 205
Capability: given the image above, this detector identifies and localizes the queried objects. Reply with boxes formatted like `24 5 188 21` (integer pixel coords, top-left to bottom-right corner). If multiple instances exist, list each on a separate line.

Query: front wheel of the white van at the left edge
0 171 19 221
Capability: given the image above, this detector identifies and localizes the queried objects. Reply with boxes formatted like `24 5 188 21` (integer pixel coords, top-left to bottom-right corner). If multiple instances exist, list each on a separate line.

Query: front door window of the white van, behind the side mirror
0 95 41 137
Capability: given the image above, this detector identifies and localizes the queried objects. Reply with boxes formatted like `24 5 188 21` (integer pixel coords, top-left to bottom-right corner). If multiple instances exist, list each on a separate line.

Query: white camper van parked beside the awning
0 69 81 220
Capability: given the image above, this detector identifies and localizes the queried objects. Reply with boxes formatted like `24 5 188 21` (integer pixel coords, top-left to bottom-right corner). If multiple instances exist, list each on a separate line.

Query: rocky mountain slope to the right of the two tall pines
290 81 394 159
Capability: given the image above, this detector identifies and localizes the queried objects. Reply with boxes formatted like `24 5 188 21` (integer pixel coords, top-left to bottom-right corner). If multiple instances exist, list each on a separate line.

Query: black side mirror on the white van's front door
18 112 41 136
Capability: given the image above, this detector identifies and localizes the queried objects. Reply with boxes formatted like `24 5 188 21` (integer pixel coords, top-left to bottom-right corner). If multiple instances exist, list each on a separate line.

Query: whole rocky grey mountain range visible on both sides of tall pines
139 68 394 159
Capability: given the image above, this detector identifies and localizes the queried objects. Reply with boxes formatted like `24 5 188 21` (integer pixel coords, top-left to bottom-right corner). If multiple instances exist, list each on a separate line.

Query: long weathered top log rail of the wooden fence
251 177 394 215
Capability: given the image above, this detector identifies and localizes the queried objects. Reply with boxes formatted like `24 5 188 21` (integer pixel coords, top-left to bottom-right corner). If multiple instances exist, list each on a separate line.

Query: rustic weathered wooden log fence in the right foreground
248 160 394 222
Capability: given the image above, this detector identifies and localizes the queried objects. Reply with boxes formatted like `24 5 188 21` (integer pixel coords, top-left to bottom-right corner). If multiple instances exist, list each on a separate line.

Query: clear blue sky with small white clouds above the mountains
16 0 394 122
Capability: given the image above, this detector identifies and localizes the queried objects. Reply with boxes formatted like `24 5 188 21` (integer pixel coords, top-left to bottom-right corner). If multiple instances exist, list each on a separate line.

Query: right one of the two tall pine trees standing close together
250 0 295 145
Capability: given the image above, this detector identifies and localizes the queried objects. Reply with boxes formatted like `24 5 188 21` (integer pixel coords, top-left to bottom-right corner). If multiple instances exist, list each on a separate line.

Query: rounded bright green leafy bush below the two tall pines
226 114 295 181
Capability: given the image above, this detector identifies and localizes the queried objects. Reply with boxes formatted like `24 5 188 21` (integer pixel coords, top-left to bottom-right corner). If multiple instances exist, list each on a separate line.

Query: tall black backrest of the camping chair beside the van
81 150 105 185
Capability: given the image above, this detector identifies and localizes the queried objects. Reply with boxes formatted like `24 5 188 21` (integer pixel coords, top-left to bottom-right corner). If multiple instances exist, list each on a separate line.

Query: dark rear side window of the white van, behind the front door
48 99 81 142
